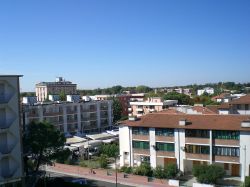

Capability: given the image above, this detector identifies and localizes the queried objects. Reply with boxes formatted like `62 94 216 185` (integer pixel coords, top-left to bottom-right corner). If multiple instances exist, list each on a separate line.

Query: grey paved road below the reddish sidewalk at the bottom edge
46 171 131 187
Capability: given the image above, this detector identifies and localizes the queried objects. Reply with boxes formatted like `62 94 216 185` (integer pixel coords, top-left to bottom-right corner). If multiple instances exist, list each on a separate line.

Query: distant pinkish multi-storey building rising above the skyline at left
36 77 76 102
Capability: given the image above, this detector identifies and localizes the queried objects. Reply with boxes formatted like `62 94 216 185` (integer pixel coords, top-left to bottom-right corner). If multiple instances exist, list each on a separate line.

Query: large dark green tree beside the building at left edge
23 122 66 171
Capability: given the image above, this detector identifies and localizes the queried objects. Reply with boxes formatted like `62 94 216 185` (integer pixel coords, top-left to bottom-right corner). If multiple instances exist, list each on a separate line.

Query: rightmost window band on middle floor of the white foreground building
213 146 240 157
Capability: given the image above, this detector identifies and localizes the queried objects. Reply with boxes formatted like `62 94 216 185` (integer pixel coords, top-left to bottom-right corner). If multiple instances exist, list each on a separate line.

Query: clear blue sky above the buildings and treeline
0 0 250 91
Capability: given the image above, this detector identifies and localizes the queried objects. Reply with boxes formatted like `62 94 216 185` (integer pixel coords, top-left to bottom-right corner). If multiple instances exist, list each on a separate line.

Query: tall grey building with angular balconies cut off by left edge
0 75 23 186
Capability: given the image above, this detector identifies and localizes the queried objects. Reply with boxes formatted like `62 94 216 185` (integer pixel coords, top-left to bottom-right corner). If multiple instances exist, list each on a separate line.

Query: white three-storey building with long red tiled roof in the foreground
119 113 250 180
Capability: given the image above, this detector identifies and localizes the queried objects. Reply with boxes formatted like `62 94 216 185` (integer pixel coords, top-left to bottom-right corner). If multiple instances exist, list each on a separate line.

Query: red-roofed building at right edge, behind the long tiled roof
218 95 250 115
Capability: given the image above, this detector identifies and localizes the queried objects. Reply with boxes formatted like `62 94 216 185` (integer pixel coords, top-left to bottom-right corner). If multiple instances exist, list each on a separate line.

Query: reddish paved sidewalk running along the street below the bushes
46 164 172 187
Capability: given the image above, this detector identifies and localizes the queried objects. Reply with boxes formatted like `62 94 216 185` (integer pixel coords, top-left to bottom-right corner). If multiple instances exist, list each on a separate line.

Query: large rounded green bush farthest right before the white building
192 164 225 184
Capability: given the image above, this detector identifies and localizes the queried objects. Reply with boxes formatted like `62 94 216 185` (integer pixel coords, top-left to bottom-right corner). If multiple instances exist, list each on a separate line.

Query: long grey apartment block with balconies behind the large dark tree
23 100 113 136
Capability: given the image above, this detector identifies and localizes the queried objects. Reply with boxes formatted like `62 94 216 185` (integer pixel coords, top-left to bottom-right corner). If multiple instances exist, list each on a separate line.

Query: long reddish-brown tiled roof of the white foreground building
122 113 250 131
